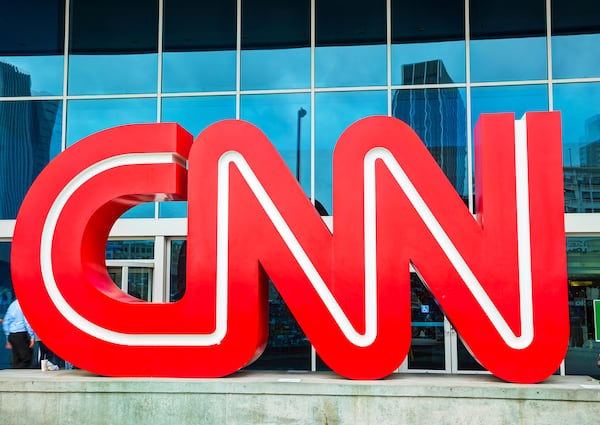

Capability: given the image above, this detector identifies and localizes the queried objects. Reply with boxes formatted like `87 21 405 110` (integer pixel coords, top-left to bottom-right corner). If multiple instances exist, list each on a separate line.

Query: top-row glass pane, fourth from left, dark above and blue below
241 0 310 90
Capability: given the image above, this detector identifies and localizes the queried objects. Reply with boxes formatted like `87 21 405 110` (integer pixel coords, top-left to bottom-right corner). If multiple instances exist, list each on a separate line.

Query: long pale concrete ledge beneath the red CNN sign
0 370 600 425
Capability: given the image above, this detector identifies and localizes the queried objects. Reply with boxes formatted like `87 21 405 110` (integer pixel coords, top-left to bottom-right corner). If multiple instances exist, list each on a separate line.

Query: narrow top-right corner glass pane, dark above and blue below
552 0 600 78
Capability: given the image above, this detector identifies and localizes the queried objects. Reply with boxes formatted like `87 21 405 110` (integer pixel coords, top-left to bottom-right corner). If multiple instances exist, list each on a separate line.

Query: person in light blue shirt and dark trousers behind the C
2 300 35 369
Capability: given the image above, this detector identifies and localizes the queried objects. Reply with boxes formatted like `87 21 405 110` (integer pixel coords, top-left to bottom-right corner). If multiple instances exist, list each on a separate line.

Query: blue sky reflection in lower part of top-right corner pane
552 34 600 78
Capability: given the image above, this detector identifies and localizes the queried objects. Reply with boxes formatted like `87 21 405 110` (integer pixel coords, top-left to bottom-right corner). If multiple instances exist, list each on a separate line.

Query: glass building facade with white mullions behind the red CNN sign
0 0 600 375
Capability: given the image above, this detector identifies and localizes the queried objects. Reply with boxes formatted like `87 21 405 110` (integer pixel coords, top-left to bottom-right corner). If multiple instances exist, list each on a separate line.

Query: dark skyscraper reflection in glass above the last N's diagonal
392 60 467 195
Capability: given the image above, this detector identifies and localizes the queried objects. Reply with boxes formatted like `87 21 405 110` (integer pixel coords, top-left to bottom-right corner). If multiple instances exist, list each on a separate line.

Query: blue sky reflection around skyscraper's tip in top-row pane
392 41 466 84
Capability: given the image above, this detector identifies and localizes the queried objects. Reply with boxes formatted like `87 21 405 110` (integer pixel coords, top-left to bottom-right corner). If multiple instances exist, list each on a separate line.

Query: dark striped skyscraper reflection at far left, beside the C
0 62 59 219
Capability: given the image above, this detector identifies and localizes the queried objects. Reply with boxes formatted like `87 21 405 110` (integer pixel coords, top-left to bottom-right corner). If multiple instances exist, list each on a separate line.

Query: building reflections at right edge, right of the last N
564 115 600 213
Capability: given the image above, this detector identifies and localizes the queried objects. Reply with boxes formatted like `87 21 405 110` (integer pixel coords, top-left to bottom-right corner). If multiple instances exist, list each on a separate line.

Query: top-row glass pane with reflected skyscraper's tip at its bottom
392 0 466 84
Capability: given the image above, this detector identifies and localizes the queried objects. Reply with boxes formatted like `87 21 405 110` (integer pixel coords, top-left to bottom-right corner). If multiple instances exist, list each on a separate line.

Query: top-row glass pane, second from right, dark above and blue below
470 0 547 82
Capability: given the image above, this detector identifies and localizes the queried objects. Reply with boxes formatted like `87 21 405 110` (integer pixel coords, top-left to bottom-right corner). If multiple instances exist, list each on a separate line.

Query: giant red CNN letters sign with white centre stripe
11 113 569 383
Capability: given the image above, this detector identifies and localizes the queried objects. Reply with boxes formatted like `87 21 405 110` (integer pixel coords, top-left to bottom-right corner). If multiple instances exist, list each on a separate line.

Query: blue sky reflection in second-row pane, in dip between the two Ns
315 91 387 214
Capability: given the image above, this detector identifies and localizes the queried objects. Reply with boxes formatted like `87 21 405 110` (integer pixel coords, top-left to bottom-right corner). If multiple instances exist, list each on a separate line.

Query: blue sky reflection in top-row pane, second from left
69 53 158 95
